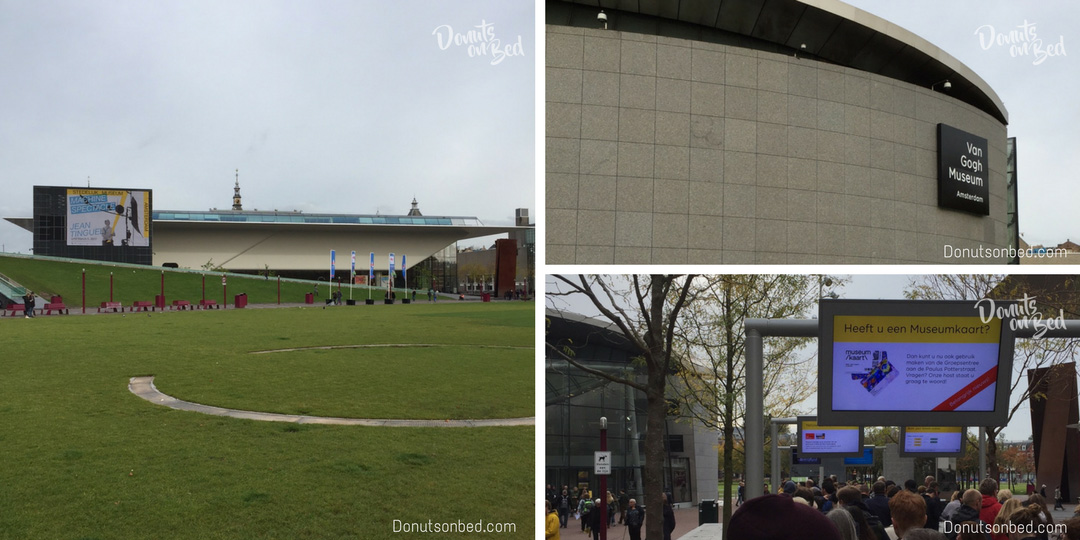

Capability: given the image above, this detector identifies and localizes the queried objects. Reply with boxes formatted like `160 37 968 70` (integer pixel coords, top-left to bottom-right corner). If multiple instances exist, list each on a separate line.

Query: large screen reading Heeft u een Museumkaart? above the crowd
818 299 1013 426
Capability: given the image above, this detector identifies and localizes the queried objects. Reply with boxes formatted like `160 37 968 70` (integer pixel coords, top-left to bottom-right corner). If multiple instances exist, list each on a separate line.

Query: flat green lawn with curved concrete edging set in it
0 298 536 540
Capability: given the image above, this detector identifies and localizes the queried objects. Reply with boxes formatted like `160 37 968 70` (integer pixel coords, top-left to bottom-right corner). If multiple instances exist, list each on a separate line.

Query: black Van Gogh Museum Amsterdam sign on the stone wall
937 124 990 216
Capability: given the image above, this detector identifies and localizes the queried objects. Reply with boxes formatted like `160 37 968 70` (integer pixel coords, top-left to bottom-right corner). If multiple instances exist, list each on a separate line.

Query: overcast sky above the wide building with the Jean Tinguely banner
0 0 536 253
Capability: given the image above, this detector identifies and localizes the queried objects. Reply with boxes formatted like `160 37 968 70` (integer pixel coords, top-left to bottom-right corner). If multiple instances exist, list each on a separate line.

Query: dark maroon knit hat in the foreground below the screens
728 495 841 540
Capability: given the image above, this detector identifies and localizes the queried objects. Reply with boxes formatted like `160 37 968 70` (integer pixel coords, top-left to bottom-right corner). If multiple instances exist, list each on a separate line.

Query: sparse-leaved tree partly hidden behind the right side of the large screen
906 274 1080 480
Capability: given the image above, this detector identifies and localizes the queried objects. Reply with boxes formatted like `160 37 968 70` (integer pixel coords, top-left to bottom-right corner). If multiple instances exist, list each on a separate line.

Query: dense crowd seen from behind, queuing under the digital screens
728 476 1080 540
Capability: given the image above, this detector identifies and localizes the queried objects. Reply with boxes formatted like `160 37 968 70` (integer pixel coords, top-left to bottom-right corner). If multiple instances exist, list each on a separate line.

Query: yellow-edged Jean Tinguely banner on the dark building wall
67 189 150 246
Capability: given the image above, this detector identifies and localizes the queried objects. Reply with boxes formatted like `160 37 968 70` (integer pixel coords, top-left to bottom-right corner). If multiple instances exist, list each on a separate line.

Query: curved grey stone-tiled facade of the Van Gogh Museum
545 0 1010 264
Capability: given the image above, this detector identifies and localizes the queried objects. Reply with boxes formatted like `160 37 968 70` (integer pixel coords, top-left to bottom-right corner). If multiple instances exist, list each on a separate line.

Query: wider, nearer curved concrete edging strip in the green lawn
127 376 536 428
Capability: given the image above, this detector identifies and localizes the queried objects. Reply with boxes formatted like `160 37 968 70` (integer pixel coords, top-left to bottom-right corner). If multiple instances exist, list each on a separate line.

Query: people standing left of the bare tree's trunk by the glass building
544 484 675 540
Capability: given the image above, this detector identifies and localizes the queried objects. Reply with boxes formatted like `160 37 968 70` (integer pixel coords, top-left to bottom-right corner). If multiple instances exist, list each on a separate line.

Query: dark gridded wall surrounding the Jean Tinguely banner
33 186 153 265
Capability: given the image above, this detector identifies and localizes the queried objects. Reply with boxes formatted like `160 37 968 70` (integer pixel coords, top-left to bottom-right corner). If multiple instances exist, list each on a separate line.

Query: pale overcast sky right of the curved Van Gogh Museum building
846 0 1080 245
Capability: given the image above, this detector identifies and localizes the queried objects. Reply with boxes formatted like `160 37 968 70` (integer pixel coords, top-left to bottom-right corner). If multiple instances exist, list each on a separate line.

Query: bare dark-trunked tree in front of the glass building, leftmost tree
548 274 694 538
